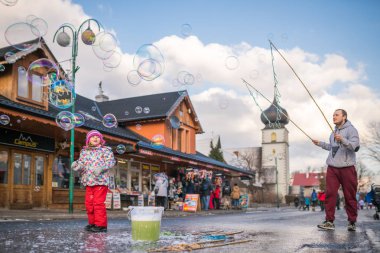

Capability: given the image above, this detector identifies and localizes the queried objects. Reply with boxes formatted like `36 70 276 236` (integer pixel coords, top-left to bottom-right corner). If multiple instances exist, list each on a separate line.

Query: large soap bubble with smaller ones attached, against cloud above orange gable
127 44 165 86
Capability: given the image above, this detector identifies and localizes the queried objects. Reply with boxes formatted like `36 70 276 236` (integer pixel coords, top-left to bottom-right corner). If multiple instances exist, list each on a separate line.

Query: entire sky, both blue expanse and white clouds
0 0 380 170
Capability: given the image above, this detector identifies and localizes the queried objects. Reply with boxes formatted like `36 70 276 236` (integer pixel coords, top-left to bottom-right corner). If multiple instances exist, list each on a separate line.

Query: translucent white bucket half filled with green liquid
129 206 164 241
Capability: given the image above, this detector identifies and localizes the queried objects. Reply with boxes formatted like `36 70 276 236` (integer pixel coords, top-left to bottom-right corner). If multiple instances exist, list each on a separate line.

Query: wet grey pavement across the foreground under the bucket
0 208 380 253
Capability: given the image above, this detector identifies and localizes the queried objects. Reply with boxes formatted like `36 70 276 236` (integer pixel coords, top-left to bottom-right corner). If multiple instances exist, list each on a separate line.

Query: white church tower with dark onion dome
261 97 290 203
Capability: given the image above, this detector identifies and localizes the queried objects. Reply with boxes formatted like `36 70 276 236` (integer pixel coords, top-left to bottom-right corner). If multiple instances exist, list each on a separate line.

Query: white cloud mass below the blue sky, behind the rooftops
0 0 380 172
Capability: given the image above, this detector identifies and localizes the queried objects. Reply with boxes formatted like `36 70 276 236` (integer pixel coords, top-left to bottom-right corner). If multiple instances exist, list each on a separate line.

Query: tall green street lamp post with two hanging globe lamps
53 19 101 213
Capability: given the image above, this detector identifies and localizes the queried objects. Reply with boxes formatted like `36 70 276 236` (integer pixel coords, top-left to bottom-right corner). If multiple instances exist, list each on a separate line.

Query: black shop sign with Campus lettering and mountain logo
0 128 55 152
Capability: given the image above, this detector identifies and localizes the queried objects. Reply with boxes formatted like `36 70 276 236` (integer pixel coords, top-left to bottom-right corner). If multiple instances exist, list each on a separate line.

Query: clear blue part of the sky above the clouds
73 0 380 90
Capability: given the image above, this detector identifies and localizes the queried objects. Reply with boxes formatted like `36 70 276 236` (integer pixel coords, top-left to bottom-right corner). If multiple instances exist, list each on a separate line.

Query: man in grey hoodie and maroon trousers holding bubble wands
313 109 360 231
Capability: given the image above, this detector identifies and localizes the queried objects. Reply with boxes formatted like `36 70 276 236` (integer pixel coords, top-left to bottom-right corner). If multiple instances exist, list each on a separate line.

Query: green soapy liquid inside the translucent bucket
132 220 161 241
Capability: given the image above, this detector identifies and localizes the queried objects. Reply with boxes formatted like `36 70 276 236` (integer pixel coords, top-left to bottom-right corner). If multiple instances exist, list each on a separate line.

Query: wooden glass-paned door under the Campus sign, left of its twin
10 152 32 209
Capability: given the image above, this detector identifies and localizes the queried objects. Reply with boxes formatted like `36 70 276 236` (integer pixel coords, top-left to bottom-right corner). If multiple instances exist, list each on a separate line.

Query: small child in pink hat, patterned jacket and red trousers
72 130 116 232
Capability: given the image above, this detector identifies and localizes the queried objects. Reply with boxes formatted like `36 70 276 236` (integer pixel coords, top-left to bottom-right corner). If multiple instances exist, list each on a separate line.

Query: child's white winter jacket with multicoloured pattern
71 146 116 186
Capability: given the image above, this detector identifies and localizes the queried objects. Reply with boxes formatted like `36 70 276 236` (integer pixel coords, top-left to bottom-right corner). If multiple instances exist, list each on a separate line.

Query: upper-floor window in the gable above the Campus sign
17 66 44 103
